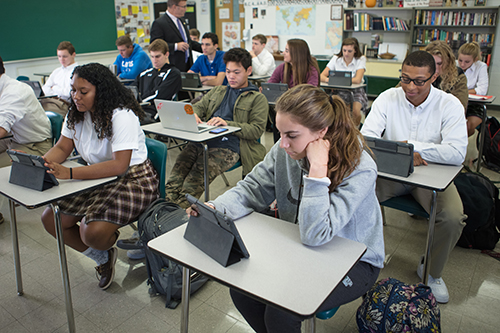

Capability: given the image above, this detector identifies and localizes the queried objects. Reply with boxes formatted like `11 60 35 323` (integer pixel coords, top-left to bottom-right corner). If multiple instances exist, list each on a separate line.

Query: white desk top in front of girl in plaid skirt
0 161 117 208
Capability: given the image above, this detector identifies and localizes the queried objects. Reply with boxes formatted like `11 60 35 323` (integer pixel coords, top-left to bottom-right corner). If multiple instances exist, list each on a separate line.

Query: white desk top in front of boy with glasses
378 163 463 192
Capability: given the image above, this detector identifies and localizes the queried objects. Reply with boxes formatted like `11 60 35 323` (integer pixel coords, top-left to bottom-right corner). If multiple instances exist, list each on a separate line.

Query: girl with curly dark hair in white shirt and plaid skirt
42 63 158 289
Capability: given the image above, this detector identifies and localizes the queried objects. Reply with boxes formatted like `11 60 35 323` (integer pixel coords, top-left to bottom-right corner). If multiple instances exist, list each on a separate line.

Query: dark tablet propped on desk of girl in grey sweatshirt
184 194 250 267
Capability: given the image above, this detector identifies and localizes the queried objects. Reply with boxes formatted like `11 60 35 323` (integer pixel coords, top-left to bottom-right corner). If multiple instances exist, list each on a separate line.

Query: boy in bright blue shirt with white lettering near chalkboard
115 36 153 79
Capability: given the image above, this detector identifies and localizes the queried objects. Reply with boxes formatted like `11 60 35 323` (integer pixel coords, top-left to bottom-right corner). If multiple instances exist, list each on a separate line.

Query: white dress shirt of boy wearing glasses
361 86 468 165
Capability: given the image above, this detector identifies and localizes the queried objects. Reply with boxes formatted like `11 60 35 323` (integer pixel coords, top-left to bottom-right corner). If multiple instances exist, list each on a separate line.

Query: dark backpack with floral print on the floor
356 278 441 333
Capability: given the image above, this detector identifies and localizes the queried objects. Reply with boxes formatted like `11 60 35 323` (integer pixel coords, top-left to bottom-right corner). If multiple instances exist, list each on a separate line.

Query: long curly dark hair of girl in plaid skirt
68 63 145 139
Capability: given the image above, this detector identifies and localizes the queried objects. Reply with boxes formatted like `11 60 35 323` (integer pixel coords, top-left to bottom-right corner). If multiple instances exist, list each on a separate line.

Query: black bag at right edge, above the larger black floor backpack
476 117 500 171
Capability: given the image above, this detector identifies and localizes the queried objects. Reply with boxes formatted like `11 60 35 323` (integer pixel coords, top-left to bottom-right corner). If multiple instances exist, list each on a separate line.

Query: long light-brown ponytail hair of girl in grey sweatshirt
276 84 364 192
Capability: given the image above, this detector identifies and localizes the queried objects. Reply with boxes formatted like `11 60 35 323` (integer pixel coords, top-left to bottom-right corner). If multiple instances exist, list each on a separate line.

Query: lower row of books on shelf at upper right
413 29 495 48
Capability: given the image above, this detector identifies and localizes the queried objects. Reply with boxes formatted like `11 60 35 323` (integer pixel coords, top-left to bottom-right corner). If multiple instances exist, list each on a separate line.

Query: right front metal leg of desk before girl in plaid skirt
50 203 75 333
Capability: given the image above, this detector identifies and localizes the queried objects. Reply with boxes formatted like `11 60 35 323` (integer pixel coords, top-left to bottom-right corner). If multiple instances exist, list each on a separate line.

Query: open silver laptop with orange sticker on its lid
155 99 217 133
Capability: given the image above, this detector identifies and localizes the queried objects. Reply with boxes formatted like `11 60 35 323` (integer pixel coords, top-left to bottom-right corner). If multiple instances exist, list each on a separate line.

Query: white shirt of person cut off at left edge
0 74 52 144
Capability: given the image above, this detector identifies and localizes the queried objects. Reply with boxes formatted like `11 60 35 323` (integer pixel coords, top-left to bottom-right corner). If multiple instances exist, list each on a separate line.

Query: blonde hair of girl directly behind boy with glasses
425 40 458 92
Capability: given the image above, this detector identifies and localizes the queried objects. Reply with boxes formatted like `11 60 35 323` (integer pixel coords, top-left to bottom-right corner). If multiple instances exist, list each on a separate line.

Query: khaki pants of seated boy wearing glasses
377 179 467 278
